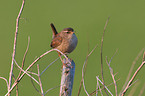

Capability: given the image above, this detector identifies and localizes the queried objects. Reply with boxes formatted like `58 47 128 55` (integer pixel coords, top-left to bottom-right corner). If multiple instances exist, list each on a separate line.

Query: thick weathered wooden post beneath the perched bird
59 58 75 96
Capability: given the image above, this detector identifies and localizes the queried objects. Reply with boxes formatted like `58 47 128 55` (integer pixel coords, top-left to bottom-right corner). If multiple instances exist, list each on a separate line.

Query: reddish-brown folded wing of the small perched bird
50 34 62 48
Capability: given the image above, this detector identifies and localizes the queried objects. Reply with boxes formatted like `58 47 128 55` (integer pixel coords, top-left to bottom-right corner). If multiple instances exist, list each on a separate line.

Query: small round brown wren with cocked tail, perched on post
50 23 78 62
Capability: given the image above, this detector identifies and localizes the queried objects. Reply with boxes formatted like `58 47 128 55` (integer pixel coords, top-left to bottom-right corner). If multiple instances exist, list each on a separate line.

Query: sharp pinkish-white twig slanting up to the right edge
121 61 145 96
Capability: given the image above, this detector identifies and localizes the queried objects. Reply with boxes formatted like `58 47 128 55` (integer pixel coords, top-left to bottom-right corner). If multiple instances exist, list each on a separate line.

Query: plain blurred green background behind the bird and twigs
0 0 145 96
